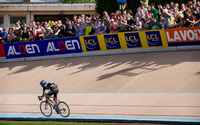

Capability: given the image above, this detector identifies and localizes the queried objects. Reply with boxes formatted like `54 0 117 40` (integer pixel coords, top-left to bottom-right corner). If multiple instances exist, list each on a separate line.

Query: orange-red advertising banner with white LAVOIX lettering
165 27 200 46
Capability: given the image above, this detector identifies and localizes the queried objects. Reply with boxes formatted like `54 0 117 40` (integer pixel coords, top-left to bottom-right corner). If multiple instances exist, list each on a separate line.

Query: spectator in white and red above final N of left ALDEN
33 22 44 41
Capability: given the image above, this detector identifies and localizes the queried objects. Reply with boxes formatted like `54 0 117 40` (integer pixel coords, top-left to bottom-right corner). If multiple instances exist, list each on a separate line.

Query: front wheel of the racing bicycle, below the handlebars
40 101 52 117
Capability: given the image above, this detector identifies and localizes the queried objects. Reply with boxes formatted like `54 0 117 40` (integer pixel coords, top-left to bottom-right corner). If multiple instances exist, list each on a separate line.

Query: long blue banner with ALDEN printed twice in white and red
3 37 83 59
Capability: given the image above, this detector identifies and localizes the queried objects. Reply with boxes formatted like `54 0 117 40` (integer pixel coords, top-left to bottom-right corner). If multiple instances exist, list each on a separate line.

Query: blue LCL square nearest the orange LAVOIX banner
145 31 163 47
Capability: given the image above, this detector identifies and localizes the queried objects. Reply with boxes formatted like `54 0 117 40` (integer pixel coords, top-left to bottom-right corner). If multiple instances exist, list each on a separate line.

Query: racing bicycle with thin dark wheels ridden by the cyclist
38 96 70 117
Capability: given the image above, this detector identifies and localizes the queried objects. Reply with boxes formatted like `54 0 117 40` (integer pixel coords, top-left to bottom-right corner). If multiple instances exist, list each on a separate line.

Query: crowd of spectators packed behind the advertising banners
0 0 200 43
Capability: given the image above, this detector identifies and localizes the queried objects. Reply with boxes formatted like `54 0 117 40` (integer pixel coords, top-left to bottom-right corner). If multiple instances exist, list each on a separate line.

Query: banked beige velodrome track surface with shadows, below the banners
0 51 200 123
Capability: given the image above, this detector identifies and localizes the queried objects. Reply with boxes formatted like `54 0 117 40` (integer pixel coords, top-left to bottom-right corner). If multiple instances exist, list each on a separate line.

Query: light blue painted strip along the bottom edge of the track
0 114 200 123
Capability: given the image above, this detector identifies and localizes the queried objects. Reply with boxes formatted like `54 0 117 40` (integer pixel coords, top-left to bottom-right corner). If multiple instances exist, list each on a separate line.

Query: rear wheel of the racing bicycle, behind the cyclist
58 101 70 117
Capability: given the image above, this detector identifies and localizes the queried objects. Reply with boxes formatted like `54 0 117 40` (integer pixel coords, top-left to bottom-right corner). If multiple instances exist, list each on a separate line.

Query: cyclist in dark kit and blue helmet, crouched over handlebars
40 80 59 108
